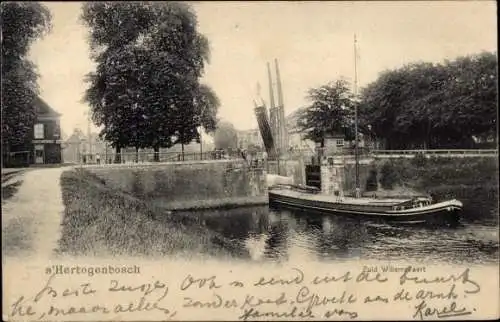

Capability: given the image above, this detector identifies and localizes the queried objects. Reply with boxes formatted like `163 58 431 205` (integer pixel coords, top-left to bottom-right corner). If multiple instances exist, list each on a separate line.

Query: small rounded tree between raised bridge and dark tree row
297 80 354 146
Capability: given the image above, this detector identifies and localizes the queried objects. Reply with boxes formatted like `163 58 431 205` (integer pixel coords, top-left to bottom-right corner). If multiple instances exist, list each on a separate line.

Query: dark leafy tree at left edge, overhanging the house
1 2 51 151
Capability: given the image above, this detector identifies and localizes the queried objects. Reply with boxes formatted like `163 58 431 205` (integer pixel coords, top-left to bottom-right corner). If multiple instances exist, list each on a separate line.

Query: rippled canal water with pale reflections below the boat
178 206 499 264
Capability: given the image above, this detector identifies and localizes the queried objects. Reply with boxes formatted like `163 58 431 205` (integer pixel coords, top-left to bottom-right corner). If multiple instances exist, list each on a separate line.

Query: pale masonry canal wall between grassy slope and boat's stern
89 161 267 210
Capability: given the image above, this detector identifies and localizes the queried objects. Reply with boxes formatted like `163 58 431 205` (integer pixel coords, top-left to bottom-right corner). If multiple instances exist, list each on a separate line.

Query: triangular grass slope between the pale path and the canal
59 169 248 257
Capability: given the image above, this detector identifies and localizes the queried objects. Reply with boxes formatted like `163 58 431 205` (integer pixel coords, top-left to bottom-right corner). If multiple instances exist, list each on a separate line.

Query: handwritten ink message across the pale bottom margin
8 266 481 321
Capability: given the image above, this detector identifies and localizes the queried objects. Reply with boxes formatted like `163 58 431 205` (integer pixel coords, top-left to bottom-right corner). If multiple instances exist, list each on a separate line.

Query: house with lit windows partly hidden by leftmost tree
30 97 62 164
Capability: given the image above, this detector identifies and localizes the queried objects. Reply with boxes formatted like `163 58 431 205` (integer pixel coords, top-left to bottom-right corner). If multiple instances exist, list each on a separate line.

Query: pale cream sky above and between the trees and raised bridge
30 0 497 135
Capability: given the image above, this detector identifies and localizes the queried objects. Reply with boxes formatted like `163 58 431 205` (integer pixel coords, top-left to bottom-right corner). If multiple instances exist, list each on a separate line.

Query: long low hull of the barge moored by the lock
269 191 462 225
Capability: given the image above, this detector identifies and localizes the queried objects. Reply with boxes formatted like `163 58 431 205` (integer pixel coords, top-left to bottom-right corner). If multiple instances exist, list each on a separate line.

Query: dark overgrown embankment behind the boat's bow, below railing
361 157 498 221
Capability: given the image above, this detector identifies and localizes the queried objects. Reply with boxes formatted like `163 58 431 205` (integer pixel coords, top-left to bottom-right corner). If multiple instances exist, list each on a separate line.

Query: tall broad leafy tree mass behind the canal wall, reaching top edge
82 2 219 160
